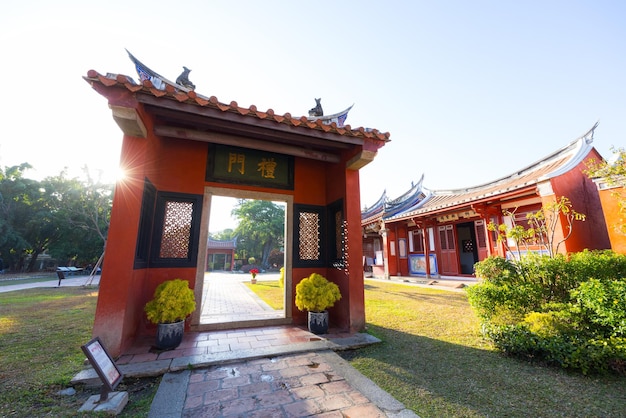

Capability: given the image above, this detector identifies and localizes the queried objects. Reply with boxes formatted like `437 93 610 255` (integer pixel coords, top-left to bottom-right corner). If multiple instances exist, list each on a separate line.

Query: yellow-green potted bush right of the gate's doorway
296 273 341 334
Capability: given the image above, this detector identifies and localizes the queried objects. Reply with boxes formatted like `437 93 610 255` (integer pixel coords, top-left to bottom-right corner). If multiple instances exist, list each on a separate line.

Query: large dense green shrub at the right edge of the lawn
467 251 626 374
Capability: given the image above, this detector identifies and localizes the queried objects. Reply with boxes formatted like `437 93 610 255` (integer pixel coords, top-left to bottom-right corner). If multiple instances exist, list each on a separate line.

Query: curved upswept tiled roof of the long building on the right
383 123 598 221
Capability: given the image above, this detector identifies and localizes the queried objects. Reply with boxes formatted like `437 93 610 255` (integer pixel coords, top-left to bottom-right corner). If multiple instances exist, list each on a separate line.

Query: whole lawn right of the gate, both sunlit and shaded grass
343 280 626 418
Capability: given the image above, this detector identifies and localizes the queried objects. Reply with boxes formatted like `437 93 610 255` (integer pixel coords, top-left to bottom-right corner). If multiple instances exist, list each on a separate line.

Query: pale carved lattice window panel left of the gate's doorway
159 201 193 259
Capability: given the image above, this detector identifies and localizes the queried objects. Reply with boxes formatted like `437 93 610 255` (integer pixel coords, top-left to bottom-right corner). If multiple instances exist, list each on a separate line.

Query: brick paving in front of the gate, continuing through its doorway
72 274 417 418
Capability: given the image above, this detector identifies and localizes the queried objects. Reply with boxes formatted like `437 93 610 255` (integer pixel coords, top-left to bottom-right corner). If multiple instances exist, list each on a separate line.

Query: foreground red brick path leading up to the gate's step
183 353 387 418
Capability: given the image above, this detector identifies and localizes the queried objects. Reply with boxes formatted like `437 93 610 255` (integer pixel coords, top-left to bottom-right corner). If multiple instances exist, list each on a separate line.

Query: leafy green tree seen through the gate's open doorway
232 199 285 267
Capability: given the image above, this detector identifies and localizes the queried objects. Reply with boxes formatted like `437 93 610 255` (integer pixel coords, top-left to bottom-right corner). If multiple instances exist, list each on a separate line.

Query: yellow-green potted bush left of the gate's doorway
144 279 196 350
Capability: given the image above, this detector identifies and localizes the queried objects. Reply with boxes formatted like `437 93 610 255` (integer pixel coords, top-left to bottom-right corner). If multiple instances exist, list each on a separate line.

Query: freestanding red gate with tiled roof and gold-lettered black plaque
84 54 389 356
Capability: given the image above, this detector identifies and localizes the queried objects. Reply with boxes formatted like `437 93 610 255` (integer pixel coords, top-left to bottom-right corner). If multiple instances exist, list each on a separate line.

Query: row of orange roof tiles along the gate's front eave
84 70 390 142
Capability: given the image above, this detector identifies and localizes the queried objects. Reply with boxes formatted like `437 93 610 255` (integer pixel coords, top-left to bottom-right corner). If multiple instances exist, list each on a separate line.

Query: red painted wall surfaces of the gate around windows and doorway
93 105 365 356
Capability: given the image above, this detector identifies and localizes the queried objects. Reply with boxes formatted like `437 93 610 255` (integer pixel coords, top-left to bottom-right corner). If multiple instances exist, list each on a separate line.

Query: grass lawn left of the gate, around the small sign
0 287 159 417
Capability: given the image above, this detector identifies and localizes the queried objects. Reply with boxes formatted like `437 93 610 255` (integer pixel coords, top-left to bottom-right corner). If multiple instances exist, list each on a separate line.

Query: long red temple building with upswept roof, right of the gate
361 124 611 278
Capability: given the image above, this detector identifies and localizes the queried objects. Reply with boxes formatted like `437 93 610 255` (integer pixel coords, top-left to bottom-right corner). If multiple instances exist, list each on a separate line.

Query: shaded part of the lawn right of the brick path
342 325 626 418
